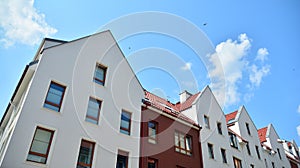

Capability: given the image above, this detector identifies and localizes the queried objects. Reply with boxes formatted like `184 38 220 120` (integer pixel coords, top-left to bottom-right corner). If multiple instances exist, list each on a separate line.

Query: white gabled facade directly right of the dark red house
182 86 233 168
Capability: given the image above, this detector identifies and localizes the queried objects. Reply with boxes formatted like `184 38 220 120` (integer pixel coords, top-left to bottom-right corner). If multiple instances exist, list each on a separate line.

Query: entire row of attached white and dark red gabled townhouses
0 31 300 168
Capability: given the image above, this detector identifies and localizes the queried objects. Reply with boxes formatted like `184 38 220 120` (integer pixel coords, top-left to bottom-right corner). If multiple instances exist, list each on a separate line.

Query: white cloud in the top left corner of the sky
0 0 57 47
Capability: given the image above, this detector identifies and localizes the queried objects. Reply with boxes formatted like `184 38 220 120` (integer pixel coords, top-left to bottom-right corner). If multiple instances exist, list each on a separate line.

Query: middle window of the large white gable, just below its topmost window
85 97 101 124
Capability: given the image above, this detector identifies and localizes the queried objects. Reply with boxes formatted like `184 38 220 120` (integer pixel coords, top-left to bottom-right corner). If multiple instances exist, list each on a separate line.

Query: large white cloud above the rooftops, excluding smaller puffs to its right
209 34 251 105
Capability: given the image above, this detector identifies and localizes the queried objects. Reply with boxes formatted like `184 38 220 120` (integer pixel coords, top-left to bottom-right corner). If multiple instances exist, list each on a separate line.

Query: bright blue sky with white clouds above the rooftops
0 0 300 145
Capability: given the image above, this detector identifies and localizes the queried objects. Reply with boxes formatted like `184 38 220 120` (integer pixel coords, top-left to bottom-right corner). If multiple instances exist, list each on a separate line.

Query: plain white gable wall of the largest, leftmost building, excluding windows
2 32 144 168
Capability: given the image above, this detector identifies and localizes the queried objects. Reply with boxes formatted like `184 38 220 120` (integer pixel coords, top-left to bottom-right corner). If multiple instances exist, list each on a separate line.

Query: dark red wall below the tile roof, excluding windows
140 108 203 168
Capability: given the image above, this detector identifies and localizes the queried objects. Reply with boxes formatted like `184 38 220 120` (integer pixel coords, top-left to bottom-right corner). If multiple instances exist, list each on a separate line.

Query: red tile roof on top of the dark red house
144 90 198 125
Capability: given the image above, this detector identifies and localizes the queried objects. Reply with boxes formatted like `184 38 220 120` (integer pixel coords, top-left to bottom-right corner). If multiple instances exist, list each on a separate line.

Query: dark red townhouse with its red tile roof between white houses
140 91 203 168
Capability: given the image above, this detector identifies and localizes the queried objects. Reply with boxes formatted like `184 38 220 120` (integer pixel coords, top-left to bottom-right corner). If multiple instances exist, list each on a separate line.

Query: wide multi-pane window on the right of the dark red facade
175 132 192 156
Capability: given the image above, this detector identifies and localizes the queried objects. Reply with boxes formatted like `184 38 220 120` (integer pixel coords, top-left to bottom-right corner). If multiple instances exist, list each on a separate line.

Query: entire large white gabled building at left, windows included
0 31 144 168
